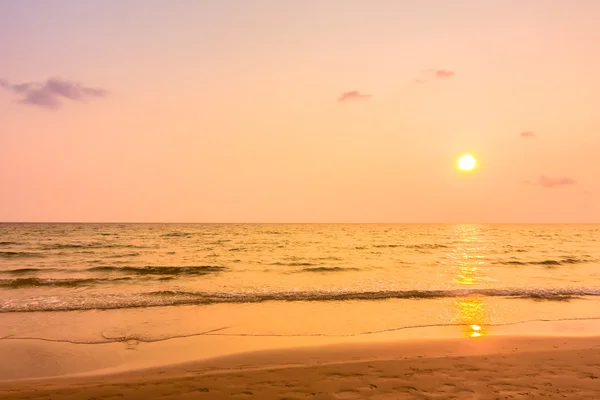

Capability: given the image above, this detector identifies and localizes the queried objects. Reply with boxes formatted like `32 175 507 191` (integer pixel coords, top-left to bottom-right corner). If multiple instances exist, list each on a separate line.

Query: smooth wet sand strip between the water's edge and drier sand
0 319 600 384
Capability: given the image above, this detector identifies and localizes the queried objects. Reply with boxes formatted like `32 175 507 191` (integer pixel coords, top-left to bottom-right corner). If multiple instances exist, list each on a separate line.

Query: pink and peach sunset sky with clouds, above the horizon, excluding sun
0 0 600 223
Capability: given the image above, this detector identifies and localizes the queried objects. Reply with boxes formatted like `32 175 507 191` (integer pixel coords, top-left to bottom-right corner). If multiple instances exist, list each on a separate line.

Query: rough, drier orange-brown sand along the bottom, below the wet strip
0 337 600 400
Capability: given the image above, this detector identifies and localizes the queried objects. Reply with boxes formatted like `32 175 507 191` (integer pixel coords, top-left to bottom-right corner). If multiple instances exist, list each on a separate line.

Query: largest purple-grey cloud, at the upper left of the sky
0 78 108 110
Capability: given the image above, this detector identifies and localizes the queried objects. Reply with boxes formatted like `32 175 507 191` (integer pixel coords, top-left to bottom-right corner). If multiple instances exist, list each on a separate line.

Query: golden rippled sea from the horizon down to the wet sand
0 223 600 343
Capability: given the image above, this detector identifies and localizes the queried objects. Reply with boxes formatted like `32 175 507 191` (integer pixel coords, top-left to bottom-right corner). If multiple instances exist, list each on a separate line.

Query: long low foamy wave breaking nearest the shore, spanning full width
0 288 600 313
